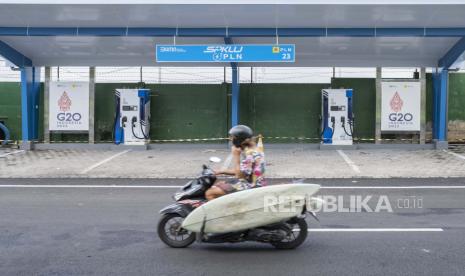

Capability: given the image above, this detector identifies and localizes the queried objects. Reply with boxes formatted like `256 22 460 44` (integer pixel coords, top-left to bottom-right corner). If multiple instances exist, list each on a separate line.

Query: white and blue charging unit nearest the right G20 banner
321 89 354 145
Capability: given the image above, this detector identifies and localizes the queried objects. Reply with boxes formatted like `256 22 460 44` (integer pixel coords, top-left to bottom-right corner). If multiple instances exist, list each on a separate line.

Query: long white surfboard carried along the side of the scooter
182 184 320 233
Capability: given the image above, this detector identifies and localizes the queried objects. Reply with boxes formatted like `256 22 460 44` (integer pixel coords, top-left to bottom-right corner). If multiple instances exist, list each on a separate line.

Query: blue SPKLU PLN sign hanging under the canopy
156 44 295 62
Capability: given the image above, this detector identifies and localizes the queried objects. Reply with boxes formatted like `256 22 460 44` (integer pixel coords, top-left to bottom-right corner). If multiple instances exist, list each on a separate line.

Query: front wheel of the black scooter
157 214 195 248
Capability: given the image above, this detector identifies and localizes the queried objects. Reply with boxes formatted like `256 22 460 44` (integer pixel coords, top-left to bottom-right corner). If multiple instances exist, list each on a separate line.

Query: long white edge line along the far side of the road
0 184 465 190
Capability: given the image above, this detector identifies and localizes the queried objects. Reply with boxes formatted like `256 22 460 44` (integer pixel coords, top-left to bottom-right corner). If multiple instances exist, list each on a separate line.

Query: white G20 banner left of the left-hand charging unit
48 82 89 131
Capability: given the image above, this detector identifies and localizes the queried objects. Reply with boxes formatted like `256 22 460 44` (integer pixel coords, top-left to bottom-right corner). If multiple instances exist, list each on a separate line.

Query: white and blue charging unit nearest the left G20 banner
114 89 150 145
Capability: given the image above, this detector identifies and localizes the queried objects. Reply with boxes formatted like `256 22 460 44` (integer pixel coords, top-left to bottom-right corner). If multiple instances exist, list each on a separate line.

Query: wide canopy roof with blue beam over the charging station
0 0 465 67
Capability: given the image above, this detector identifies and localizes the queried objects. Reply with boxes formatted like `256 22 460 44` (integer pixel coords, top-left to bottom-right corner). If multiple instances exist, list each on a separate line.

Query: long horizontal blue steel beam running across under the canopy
0 27 465 37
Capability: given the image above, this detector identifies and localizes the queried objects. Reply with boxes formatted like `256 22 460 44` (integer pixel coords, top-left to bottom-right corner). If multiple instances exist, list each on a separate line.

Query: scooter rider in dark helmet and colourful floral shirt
205 125 266 200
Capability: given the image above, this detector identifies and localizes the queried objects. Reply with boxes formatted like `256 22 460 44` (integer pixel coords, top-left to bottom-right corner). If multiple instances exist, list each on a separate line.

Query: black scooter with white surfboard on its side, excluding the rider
158 165 321 249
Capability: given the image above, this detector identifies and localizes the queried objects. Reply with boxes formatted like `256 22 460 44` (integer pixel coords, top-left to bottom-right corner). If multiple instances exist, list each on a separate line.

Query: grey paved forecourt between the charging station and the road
0 145 465 178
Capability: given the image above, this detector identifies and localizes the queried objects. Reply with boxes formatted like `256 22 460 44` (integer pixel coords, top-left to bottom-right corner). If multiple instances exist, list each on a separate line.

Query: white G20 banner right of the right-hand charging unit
381 82 421 131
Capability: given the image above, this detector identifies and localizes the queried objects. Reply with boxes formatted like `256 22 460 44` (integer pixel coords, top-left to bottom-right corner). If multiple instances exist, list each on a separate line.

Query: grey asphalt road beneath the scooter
0 178 465 275
